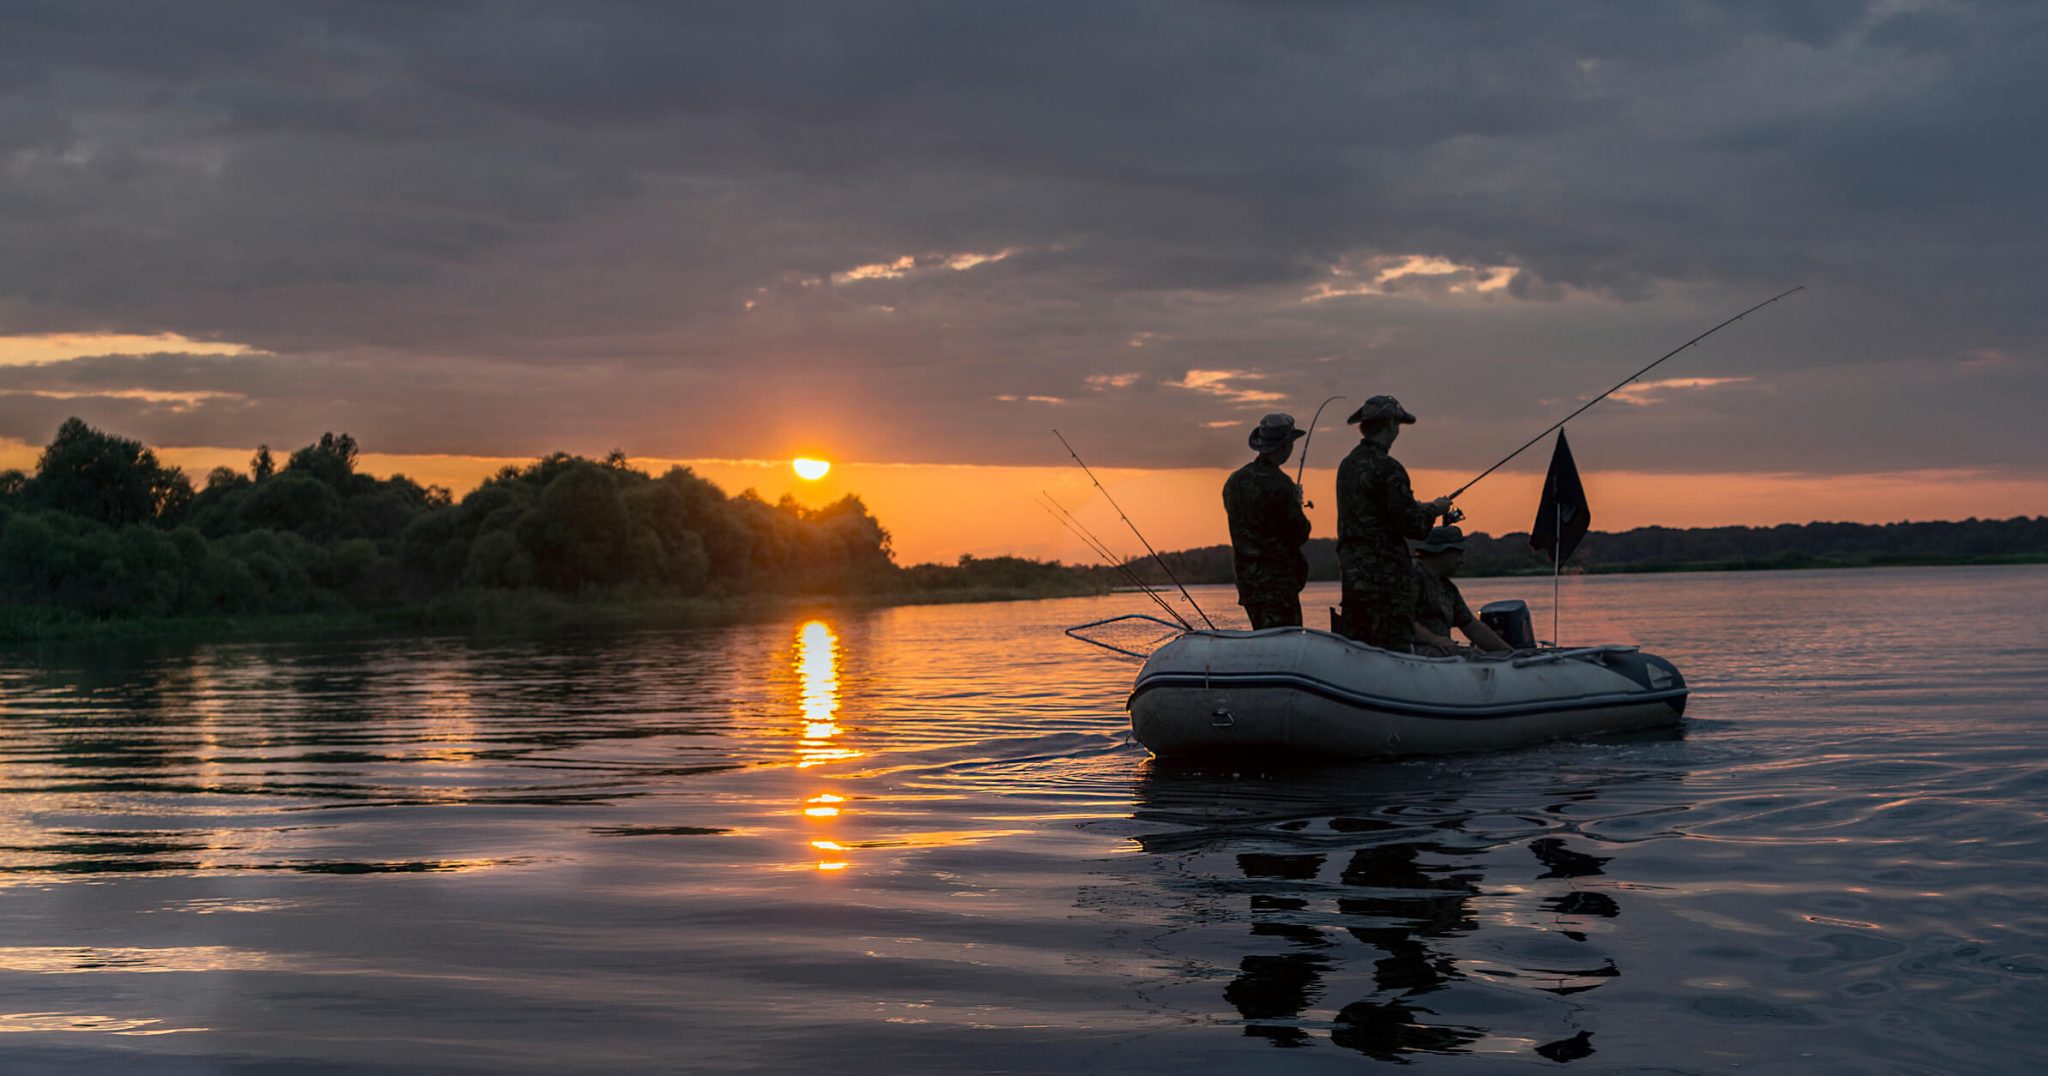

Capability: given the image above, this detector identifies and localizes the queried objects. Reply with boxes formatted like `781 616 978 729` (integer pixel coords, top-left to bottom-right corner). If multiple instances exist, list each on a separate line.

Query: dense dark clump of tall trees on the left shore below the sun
0 418 1106 637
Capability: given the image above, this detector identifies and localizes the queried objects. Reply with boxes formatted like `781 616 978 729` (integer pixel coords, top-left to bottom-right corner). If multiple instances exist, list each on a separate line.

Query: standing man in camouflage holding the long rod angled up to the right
1337 396 1450 654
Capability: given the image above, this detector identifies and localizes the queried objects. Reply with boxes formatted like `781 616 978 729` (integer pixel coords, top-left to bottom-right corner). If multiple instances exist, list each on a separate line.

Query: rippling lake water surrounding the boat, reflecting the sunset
0 568 2048 1074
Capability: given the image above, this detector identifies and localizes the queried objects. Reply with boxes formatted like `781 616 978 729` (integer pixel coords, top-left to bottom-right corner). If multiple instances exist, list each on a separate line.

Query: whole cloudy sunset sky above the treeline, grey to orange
0 0 2048 562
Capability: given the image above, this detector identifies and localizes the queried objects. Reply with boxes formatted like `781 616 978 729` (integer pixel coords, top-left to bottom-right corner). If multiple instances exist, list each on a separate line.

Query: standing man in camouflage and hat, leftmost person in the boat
1223 414 1309 629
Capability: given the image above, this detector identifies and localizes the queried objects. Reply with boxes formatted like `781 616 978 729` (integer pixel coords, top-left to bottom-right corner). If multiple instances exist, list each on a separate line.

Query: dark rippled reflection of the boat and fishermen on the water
1133 762 1669 1068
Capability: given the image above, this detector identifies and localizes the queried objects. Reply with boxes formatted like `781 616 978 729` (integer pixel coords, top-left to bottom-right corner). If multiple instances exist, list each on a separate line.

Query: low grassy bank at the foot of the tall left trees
0 580 1108 644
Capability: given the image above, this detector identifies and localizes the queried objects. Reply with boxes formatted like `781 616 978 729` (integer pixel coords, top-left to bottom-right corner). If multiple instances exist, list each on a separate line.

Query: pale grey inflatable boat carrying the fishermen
1128 627 1686 758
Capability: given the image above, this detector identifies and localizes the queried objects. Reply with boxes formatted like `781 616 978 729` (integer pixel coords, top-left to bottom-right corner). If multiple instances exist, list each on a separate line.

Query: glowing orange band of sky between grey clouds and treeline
0 443 2048 566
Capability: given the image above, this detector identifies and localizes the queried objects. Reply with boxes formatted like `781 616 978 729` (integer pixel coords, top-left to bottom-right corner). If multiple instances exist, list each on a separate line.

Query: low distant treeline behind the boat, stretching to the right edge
1133 516 2048 582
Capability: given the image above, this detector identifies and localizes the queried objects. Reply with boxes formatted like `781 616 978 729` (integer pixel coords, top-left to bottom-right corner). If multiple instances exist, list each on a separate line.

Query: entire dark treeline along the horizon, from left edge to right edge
0 418 2048 637
